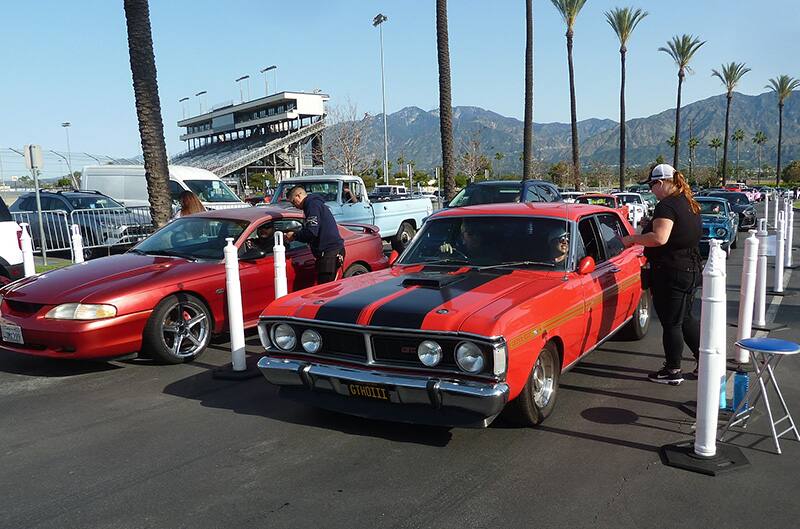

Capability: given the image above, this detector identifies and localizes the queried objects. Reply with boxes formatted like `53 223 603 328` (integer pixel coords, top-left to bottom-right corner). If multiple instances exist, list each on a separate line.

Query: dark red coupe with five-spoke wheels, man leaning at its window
0 208 388 363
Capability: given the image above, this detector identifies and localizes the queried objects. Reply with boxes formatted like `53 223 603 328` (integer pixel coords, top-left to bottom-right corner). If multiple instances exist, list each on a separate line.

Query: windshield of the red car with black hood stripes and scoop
399 216 570 270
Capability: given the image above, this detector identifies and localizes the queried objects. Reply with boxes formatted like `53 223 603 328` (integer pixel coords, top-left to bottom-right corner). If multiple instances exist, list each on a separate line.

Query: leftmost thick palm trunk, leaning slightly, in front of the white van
124 0 172 228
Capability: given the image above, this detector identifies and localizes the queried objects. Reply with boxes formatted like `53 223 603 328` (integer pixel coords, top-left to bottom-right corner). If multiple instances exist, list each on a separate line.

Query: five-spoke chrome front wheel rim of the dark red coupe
161 300 210 358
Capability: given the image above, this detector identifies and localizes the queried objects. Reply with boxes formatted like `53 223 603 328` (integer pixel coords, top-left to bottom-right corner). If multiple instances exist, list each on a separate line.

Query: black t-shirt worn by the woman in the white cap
644 195 703 270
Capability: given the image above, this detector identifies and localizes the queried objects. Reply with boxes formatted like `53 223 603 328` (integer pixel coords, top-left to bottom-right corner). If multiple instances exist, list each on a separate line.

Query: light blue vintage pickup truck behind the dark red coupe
272 175 433 252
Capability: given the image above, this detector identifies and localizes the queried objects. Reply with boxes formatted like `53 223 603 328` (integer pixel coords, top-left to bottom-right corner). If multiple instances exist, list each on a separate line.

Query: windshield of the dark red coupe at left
132 217 249 260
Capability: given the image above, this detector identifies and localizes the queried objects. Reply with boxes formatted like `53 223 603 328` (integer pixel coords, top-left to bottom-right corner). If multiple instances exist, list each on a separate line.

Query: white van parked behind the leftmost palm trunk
81 165 250 209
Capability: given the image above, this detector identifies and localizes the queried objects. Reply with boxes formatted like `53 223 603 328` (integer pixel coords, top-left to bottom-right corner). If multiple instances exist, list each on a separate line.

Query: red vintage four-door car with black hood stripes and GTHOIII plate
258 203 650 426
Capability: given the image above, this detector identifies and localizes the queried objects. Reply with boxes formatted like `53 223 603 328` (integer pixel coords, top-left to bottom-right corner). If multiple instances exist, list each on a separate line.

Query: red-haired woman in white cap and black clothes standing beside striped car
622 163 703 386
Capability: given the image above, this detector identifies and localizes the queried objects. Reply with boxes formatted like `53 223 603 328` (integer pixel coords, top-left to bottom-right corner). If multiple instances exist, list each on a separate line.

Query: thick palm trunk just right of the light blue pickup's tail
436 0 456 200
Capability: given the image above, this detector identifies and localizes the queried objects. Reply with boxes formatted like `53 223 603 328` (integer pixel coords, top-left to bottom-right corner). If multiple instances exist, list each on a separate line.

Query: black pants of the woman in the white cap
650 264 700 369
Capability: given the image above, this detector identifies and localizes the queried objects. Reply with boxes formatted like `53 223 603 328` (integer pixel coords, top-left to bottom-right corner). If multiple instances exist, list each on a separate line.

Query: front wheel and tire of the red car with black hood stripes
507 342 561 426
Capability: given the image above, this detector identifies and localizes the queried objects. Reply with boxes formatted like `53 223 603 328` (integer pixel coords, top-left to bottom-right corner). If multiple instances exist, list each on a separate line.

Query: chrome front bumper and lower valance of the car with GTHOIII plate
258 356 509 427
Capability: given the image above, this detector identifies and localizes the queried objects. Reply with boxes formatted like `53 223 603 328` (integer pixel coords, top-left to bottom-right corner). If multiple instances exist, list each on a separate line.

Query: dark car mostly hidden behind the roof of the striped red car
446 180 561 208
